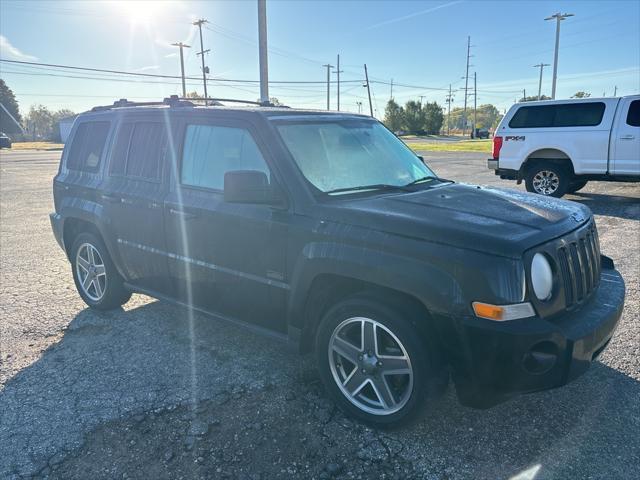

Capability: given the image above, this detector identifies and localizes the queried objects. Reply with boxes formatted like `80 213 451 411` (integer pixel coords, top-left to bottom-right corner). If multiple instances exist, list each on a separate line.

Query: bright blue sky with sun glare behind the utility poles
0 0 640 116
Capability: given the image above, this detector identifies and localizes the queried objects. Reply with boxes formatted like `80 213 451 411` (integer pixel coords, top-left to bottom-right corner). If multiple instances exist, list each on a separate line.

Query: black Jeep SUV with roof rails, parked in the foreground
51 98 625 425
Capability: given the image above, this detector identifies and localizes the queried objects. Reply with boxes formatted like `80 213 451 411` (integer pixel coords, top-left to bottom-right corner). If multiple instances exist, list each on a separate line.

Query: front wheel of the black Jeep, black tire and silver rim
315 295 448 427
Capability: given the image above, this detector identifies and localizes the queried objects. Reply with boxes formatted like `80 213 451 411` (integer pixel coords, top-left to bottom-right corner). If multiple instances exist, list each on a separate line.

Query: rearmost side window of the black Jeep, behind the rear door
67 122 110 172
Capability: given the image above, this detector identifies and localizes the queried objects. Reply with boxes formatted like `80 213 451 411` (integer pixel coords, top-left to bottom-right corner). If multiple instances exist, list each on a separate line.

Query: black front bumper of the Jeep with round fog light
451 269 625 408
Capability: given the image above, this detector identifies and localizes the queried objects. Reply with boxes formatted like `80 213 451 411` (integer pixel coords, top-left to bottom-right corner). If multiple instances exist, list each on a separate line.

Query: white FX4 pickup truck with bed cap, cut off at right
488 95 640 197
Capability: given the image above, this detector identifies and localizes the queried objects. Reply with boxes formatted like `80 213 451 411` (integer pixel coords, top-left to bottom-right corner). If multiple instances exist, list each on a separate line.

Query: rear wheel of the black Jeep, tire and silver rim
71 232 131 310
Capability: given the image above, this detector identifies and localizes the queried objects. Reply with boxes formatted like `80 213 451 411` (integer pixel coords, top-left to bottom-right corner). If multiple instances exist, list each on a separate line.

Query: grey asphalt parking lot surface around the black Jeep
0 151 640 480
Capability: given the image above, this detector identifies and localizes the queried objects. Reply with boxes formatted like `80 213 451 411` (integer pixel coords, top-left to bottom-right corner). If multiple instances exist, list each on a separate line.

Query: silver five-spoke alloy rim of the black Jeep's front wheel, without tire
328 317 413 415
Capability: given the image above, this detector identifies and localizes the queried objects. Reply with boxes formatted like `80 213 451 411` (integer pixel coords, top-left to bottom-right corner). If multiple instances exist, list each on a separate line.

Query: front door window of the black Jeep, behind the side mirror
180 125 269 190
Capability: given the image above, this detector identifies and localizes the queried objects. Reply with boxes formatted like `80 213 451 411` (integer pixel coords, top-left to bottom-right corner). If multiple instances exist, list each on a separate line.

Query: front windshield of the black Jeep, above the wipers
277 118 435 193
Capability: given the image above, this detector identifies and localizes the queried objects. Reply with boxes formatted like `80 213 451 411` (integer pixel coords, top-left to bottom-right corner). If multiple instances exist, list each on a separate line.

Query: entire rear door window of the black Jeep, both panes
109 122 167 181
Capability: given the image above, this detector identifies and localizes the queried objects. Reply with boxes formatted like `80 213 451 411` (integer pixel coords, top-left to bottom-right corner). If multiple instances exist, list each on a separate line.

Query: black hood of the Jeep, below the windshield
322 183 591 257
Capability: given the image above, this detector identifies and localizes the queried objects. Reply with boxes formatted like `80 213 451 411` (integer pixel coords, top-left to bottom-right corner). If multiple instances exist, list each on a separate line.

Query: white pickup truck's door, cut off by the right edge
611 98 640 175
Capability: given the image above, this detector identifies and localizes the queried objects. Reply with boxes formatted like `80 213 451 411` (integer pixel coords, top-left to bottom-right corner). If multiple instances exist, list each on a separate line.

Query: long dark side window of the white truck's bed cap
509 102 605 128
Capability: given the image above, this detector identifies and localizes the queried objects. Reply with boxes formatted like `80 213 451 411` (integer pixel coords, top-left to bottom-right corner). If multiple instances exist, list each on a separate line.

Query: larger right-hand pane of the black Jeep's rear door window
125 123 166 180
